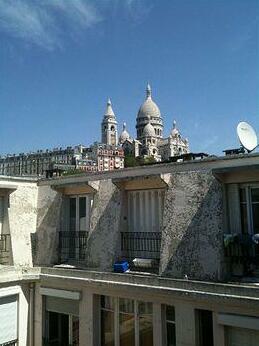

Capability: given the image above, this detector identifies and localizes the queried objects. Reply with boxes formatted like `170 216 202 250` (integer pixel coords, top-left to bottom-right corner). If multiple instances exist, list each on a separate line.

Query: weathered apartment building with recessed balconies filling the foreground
0 154 259 346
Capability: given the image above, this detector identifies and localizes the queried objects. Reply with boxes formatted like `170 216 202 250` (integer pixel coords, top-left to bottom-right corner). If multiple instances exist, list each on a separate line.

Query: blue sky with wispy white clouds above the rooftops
0 0 259 154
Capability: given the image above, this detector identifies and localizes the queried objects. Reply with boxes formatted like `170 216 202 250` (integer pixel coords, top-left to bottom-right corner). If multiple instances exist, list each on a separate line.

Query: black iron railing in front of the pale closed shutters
121 232 161 259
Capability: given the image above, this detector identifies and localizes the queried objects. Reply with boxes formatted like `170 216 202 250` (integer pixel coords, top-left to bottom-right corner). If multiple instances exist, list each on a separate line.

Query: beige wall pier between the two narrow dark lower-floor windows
175 304 196 346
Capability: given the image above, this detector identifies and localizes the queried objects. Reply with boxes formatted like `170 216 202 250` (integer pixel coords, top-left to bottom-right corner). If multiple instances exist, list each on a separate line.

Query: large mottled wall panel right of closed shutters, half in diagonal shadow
160 171 223 280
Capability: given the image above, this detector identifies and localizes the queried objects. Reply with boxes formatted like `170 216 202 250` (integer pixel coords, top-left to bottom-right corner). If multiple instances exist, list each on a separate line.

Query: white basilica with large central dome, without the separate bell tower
119 84 189 161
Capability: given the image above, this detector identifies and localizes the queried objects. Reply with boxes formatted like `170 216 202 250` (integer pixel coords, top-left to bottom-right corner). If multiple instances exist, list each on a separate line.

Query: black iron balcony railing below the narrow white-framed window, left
59 231 88 263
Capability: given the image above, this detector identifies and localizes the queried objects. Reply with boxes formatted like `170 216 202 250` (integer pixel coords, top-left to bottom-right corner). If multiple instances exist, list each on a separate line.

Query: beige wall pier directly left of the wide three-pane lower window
79 289 100 346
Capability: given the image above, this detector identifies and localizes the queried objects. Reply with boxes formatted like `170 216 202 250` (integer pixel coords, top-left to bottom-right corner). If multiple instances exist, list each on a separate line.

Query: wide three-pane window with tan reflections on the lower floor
101 296 153 346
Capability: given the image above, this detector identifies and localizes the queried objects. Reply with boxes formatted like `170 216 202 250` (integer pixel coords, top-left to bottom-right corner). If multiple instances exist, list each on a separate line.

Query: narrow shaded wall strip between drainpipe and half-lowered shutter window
34 284 45 346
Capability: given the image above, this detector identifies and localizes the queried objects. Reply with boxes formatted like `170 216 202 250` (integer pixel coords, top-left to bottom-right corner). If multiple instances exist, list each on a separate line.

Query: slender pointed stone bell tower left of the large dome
102 99 118 145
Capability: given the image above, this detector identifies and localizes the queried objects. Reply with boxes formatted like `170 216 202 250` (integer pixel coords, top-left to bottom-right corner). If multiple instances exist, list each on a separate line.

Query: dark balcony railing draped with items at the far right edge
224 234 259 276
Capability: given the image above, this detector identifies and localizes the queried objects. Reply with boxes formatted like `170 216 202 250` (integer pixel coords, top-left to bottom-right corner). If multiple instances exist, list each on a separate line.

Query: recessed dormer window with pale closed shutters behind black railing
113 175 168 268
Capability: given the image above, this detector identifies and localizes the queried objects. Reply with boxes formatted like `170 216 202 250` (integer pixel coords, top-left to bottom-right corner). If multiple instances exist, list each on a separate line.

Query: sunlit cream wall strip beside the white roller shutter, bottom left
18 285 29 346
